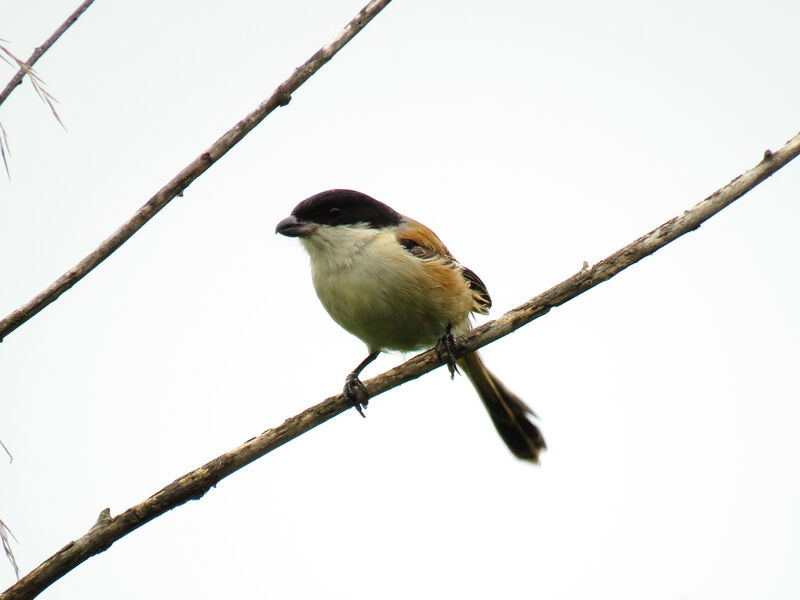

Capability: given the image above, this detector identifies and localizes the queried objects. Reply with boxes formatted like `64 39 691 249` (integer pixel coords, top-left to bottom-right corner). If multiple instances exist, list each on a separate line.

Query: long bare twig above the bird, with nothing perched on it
0 0 390 341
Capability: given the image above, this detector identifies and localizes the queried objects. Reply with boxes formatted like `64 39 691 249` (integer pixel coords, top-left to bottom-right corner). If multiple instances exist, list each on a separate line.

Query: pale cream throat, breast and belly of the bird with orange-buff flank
302 226 473 351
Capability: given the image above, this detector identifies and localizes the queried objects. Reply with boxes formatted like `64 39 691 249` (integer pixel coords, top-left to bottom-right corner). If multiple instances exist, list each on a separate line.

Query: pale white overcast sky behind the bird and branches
0 0 800 600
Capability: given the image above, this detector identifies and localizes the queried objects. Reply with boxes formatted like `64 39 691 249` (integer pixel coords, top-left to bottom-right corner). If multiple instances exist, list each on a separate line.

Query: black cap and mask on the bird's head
292 190 401 228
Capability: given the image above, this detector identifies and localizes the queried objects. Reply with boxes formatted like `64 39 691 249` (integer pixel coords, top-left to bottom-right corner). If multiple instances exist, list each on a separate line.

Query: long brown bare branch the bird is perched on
0 134 800 600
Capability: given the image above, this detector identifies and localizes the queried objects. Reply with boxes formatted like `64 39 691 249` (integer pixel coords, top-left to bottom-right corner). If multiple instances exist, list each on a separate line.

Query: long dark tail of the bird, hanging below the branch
458 352 547 462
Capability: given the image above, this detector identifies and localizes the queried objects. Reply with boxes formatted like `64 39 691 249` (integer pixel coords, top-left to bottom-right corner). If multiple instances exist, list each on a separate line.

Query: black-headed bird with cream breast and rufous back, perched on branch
275 189 546 463
